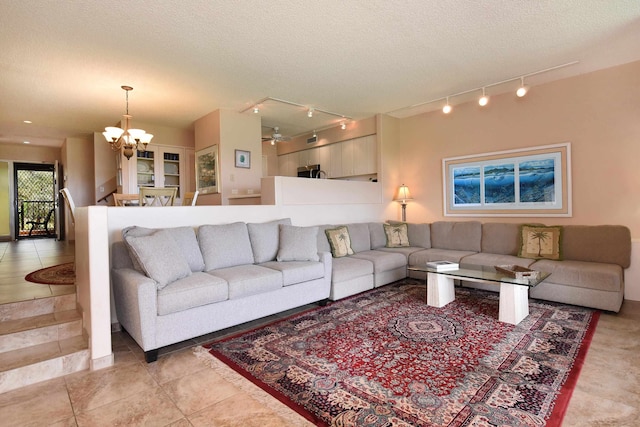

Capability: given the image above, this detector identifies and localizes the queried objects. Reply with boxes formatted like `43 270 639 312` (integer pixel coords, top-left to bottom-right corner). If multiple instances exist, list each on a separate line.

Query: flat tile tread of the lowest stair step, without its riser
0 336 89 373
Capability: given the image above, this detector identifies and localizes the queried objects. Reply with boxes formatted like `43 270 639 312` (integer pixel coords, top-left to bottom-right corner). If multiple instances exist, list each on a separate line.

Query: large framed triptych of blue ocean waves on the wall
442 142 572 217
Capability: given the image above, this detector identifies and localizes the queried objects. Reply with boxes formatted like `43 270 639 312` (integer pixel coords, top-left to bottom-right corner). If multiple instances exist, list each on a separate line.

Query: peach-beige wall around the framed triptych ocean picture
392 62 640 238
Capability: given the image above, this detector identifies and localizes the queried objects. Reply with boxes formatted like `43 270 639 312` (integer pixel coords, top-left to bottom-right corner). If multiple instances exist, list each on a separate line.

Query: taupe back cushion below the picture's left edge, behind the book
431 221 482 252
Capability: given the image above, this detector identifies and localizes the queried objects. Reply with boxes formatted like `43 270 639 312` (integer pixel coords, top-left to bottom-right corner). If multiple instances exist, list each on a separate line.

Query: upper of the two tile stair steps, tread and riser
0 309 82 354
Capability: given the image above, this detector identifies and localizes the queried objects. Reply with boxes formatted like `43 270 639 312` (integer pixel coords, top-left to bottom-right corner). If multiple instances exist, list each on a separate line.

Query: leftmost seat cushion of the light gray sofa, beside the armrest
158 273 229 316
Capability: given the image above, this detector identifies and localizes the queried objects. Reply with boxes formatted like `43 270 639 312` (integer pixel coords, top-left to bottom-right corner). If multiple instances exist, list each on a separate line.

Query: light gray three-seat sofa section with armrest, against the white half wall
111 219 332 362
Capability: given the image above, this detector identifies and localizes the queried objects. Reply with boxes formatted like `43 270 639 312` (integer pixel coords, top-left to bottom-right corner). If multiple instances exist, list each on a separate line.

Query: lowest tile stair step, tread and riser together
0 335 91 393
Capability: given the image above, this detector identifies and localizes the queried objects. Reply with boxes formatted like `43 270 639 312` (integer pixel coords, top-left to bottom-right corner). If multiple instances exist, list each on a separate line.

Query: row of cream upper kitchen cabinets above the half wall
278 135 378 178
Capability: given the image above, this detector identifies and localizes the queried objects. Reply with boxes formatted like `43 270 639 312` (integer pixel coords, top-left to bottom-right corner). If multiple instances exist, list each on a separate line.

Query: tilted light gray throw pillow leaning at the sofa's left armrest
125 230 191 290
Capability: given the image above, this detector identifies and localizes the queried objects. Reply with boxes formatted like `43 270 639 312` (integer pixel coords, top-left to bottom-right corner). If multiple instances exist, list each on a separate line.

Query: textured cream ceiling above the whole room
0 0 640 147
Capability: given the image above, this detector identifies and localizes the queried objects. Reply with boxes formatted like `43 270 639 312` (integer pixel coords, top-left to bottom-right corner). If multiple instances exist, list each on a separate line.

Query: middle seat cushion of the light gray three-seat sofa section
209 264 282 299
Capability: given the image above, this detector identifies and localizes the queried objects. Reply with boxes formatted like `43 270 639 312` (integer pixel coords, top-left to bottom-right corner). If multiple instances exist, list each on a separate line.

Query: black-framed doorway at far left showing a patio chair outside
13 163 58 239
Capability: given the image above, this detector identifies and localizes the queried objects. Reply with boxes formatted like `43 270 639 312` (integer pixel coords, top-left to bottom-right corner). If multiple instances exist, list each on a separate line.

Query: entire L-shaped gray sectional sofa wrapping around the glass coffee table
111 219 631 361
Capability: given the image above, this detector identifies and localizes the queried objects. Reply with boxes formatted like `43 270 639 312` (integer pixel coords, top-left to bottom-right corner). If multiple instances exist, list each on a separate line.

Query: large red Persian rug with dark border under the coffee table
203 279 599 426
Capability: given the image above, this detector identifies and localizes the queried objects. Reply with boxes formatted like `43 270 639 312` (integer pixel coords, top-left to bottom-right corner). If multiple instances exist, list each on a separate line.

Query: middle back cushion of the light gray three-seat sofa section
198 222 254 271
